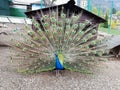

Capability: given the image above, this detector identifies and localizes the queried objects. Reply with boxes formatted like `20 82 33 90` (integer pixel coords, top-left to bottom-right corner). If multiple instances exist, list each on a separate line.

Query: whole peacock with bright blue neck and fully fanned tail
11 10 109 73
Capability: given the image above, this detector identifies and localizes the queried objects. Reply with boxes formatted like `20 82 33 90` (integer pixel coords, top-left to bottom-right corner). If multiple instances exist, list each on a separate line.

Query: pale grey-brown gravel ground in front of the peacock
0 47 120 90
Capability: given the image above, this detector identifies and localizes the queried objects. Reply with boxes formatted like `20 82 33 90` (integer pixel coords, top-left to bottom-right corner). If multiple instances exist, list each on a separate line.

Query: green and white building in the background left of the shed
0 0 50 17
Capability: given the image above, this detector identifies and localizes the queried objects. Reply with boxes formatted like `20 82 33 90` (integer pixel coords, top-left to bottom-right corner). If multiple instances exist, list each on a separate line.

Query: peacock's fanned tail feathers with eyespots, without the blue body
10 7 107 73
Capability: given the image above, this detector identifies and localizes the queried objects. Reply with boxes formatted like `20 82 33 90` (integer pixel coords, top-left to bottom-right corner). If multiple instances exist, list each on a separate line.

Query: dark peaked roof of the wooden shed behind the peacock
25 3 105 30
